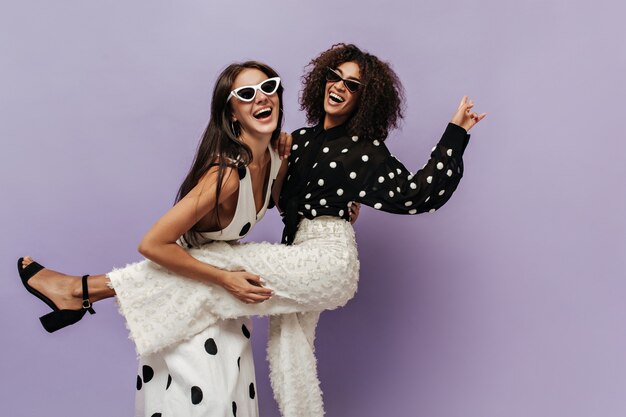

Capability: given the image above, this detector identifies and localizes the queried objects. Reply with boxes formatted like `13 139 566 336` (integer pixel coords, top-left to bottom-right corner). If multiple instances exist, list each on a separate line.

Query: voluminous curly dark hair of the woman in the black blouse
300 43 404 140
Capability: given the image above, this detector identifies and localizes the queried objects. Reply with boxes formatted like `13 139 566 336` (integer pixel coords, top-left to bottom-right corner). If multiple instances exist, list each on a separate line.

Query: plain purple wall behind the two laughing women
0 0 626 417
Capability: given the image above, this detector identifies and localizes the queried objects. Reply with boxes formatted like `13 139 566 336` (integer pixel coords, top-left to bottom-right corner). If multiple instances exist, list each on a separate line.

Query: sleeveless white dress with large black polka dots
135 147 280 417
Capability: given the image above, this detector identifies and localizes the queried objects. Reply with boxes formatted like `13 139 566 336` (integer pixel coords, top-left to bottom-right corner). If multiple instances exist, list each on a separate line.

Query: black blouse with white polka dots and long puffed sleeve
279 123 469 244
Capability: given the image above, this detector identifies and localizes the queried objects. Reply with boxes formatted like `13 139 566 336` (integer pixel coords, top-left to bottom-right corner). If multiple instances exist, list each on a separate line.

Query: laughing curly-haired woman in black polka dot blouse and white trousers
15 44 485 417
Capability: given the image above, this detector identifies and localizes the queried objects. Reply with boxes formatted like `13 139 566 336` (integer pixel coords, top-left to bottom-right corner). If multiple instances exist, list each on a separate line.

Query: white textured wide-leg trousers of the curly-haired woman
108 217 359 417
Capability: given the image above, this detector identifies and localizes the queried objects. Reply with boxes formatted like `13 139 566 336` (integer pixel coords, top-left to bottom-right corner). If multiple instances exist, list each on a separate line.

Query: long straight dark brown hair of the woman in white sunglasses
176 61 283 246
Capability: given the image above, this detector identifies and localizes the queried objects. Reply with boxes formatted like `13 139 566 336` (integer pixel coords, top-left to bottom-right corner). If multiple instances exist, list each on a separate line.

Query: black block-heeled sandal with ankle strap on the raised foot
17 258 96 333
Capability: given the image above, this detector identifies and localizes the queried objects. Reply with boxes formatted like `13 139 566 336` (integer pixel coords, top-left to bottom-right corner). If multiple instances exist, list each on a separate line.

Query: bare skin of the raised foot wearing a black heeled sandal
22 256 83 310
